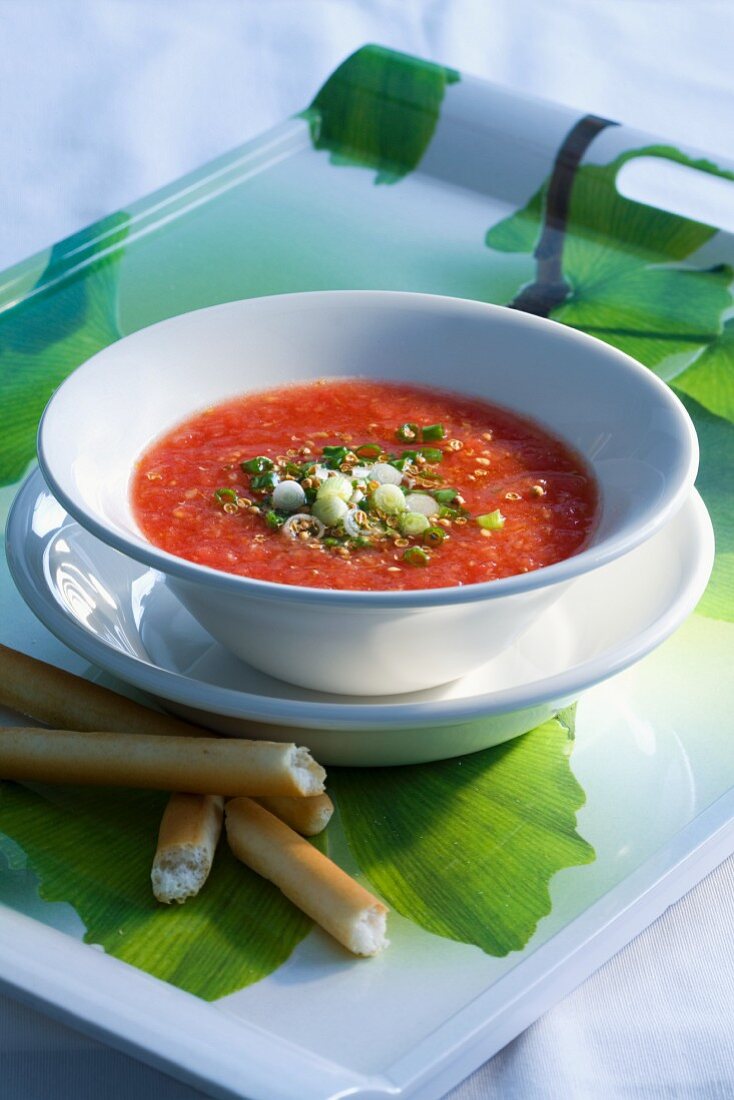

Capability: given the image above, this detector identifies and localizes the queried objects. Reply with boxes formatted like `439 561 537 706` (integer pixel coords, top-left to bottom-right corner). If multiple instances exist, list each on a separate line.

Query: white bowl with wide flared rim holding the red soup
39 290 698 695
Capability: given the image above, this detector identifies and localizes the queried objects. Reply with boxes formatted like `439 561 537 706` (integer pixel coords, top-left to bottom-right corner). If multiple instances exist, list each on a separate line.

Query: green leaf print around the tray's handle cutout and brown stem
486 145 734 376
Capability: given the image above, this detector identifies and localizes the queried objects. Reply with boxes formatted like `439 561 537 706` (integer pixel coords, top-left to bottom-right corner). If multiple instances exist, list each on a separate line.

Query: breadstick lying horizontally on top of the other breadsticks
0 728 326 795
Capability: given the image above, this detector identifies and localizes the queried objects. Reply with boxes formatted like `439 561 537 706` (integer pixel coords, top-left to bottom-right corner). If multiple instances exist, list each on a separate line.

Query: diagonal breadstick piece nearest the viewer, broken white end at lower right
226 799 388 955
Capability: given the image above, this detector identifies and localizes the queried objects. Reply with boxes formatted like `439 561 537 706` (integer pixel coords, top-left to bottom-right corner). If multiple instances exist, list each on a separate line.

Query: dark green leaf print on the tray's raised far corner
305 46 459 184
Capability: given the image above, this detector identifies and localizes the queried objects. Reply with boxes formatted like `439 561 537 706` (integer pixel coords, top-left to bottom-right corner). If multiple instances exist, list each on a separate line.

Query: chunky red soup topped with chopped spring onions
132 378 596 590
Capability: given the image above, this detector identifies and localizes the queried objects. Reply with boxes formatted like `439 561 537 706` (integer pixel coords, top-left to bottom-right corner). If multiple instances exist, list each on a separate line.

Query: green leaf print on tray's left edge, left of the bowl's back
0 213 128 485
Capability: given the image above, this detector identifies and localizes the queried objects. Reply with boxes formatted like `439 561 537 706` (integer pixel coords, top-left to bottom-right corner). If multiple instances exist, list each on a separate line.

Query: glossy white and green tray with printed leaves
0 47 734 1100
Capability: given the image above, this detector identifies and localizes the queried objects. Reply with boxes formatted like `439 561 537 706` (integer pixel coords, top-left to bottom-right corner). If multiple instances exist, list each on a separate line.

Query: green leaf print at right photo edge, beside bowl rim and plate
680 394 734 623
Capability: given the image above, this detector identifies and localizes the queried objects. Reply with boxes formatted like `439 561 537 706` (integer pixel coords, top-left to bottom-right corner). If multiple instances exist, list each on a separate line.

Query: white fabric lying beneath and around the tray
0 0 734 1100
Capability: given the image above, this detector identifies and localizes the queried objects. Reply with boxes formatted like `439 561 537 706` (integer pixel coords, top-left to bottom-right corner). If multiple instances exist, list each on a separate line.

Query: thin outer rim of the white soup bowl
37 290 699 611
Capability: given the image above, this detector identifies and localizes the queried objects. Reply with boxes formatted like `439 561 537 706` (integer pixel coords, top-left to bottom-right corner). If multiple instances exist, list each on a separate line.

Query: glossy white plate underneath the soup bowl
7 471 713 766
